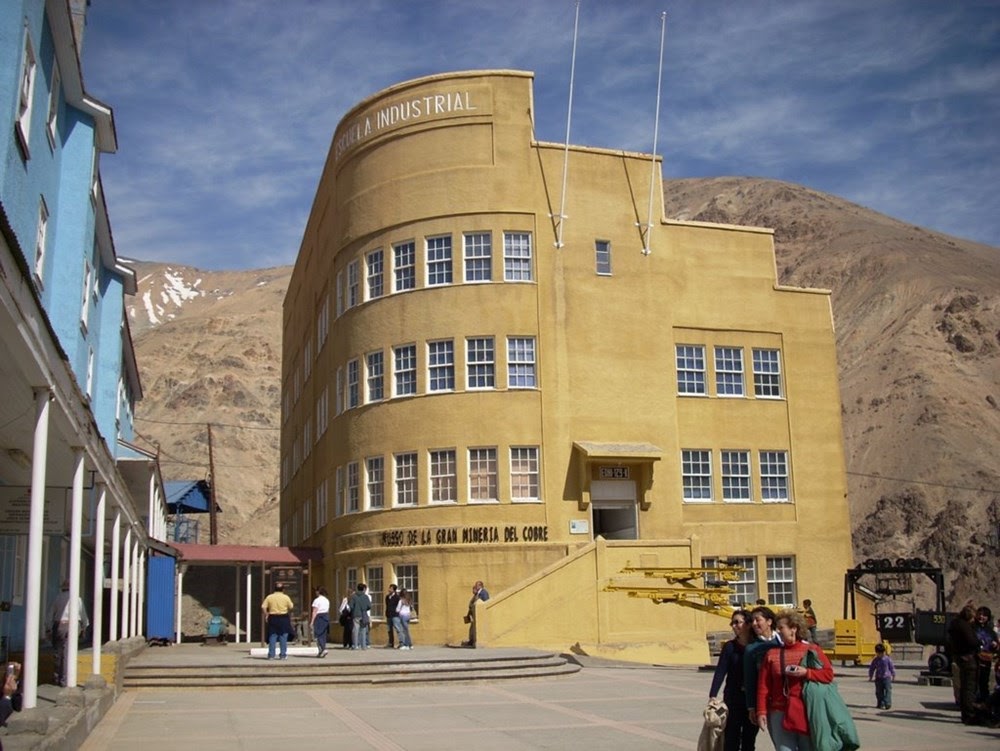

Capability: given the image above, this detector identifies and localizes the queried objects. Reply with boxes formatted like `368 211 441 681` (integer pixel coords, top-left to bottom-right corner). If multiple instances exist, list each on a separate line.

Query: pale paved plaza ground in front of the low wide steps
82 647 1000 751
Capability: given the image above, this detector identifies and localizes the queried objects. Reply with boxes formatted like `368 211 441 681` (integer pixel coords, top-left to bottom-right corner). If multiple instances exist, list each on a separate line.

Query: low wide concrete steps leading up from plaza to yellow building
122 649 580 689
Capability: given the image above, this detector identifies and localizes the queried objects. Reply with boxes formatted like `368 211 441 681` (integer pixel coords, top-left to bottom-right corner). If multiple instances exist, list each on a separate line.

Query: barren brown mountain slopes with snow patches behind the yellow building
130 177 1000 607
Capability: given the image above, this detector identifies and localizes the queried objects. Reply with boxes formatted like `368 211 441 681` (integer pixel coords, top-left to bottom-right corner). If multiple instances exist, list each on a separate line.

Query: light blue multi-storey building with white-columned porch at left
0 0 166 707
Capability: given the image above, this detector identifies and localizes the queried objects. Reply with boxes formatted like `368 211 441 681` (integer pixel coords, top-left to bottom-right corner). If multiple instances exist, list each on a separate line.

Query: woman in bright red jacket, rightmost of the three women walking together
757 610 833 751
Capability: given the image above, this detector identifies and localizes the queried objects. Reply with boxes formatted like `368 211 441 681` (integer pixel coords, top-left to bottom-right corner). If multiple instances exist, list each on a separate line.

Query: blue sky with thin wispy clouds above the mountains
83 0 1000 269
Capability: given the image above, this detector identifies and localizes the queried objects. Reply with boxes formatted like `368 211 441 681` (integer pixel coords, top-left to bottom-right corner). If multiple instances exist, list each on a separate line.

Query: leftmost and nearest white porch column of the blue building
21 389 50 709
